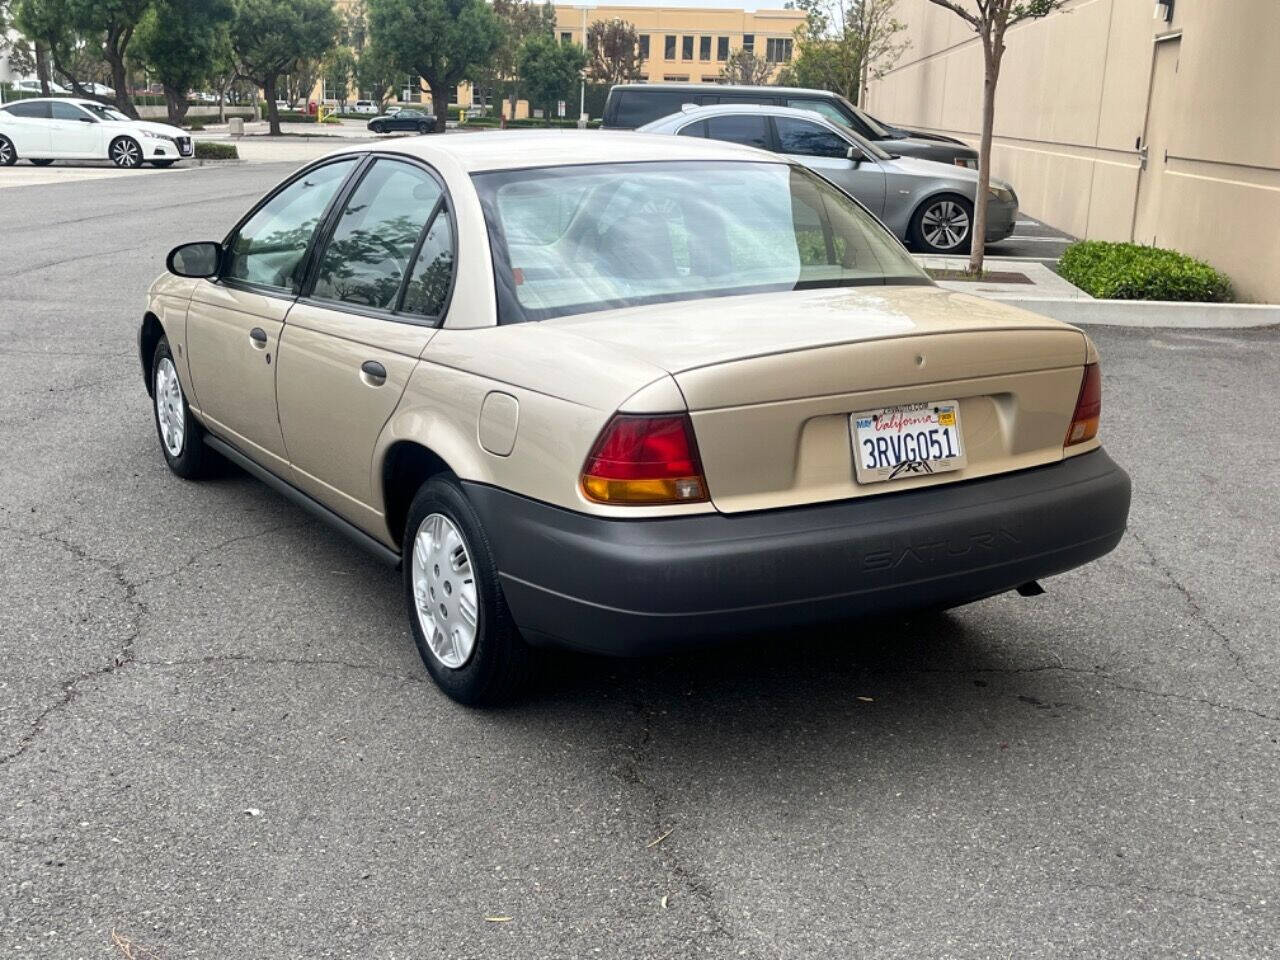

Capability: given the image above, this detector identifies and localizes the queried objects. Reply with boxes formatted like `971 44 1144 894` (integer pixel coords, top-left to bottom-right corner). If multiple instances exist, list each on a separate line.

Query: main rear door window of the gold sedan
311 160 452 310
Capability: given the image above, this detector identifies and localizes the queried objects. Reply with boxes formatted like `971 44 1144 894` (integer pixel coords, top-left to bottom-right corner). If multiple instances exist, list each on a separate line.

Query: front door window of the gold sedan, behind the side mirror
224 157 356 292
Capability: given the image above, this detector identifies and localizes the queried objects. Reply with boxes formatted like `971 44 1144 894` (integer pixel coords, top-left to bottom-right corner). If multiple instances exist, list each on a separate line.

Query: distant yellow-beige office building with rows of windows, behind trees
556 4 804 83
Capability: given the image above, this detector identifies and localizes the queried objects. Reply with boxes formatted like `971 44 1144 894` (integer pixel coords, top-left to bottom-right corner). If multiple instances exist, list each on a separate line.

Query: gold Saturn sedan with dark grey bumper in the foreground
138 131 1129 704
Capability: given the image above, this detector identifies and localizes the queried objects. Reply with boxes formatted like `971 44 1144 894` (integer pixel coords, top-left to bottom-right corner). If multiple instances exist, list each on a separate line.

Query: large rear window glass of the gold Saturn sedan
474 161 929 323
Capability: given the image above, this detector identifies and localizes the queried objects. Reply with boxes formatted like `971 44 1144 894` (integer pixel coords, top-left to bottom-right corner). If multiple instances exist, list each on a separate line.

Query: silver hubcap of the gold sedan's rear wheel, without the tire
411 513 479 669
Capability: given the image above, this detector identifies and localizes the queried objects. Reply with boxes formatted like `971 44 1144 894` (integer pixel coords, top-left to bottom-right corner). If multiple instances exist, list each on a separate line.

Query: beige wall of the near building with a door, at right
867 0 1280 302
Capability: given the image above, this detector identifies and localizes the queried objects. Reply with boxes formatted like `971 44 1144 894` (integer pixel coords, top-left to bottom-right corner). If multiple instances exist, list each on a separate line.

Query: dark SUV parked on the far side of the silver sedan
603 83 978 169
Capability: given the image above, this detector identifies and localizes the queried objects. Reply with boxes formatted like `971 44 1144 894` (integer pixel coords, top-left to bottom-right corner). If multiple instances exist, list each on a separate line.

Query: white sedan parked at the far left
0 97 193 168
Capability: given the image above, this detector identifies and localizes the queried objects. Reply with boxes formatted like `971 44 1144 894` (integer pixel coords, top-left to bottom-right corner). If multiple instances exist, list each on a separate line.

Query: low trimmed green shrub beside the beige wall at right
1057 241 1231 303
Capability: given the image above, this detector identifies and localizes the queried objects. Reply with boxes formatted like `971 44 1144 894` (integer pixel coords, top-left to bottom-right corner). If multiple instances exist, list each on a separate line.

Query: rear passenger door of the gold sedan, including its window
276 156 454 529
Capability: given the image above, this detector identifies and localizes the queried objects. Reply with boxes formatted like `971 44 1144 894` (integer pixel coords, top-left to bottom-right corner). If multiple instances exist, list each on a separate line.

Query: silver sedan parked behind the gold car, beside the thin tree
640 104 1018 253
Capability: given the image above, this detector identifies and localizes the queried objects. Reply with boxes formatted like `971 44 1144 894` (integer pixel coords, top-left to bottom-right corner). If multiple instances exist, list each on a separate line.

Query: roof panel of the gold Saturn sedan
364 129 786 173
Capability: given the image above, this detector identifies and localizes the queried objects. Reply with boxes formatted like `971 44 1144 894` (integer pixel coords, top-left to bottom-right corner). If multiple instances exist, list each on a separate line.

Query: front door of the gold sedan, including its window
187 156 360 475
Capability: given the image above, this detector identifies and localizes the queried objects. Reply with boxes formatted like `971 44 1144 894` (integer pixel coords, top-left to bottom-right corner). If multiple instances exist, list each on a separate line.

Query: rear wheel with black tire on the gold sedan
401 477 531 707
